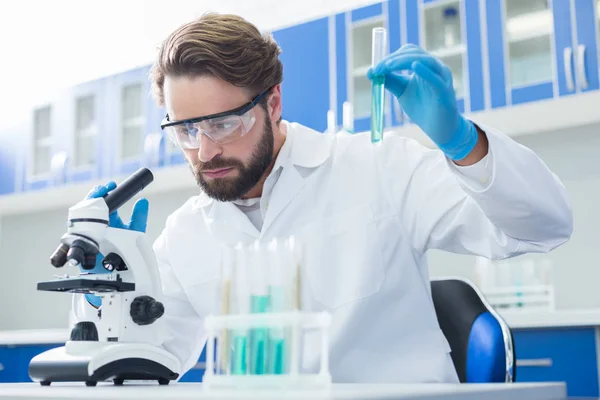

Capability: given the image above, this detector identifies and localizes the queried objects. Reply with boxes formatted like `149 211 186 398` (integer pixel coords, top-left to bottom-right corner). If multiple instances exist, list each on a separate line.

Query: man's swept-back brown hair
150 13 283 106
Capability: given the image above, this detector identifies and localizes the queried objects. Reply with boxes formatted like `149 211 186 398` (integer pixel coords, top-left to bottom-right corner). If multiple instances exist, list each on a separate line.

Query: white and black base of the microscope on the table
29 341 180 386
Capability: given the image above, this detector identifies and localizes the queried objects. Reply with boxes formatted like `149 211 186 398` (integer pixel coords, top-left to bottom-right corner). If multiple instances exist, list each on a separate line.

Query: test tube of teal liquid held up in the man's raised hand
371 27 387 143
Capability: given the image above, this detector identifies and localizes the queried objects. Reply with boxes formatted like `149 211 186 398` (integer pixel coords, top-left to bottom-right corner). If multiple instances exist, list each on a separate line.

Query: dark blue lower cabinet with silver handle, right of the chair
514 327 600 397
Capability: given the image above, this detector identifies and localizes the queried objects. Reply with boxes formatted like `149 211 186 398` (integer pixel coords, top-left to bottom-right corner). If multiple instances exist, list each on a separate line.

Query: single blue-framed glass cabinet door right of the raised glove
485 0 575 107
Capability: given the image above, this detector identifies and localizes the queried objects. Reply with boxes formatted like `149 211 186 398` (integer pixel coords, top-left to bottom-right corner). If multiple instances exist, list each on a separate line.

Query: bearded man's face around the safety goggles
164 76 273 201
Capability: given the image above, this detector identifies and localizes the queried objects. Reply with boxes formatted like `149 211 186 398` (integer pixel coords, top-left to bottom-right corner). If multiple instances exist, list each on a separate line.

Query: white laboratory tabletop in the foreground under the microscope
0 383 567 400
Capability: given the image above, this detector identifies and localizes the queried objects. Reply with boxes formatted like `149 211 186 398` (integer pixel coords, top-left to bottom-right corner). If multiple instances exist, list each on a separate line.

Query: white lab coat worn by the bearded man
76 122 572 382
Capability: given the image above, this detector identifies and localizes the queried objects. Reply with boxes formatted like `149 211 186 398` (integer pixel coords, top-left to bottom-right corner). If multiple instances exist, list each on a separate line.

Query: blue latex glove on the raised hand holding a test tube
367 44 478 160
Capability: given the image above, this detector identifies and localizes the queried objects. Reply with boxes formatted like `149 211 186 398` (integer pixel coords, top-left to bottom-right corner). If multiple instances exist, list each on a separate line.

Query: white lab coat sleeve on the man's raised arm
390 122 573 259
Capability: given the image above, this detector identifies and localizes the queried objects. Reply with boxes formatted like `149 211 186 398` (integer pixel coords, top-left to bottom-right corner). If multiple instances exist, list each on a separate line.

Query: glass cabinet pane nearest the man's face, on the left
121 83 144 160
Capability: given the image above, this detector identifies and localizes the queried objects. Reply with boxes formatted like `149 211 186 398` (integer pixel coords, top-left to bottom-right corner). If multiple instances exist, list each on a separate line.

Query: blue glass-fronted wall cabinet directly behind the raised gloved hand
334 0 485 132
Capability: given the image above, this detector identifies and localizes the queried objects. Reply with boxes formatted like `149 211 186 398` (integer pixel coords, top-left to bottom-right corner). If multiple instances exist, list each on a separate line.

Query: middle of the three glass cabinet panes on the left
73 95 96 167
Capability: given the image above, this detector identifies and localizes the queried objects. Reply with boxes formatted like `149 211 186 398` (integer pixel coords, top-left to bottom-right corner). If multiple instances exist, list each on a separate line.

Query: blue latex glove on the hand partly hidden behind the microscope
85 181 149 308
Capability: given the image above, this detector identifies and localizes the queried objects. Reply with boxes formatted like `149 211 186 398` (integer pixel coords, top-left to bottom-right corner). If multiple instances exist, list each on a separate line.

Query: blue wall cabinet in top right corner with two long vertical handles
485 0 598 108
